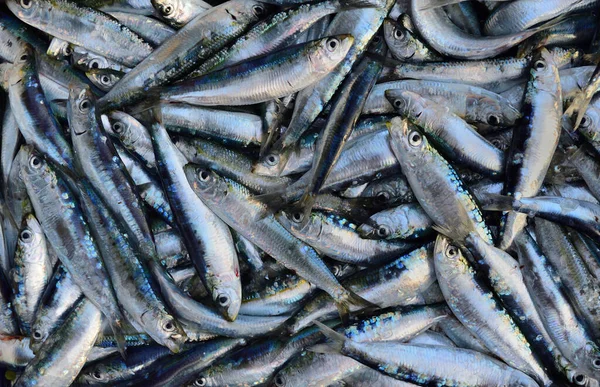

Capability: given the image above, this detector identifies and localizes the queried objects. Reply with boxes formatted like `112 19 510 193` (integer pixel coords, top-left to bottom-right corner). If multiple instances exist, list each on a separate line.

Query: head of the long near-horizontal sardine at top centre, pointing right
308 35 354 73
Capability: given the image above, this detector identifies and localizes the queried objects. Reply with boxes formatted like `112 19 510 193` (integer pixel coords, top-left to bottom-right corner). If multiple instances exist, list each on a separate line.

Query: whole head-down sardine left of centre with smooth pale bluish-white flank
150 122 242 321
